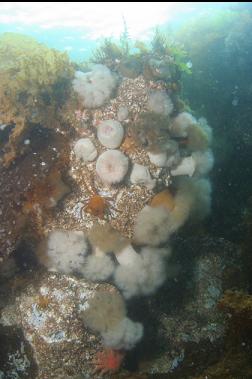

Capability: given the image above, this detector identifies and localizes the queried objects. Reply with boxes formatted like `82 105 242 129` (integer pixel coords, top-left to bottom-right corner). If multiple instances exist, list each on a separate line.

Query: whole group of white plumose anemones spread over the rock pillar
41 66 213 349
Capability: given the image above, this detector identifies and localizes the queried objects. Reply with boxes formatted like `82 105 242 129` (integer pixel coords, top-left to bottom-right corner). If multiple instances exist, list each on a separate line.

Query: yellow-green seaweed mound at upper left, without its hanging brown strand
0 33 74 122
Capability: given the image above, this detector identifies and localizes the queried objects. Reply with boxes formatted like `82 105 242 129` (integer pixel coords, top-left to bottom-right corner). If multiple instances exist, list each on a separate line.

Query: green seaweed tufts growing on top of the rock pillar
91 29 191 83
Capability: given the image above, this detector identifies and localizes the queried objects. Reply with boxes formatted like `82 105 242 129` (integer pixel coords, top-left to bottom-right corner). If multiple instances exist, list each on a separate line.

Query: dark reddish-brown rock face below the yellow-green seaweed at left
0 128 70 265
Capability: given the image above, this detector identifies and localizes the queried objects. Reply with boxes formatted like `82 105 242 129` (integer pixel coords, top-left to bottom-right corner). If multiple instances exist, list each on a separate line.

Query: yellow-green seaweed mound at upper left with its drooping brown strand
0 33 74 165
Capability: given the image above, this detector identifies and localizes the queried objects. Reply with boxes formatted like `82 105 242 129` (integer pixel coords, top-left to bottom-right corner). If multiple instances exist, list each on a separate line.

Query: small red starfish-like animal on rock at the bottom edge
93 349 125 375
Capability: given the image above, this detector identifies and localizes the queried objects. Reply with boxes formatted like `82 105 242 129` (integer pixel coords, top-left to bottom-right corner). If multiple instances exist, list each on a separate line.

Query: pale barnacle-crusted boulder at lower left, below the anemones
0 273 119 379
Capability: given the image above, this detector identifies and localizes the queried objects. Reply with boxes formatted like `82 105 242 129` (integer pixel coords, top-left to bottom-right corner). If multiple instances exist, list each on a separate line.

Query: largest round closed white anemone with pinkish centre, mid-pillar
96 150 129 184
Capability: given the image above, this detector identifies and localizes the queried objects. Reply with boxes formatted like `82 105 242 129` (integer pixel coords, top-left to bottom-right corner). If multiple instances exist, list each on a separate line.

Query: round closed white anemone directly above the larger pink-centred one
97 120 124 149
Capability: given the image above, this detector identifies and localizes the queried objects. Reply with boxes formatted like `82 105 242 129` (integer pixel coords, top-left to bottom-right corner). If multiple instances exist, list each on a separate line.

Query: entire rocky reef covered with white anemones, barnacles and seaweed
0 29 249 379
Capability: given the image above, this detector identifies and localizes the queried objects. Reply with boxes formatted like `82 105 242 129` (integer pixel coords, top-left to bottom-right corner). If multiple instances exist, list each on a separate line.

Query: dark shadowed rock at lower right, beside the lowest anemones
140 237 242 378
